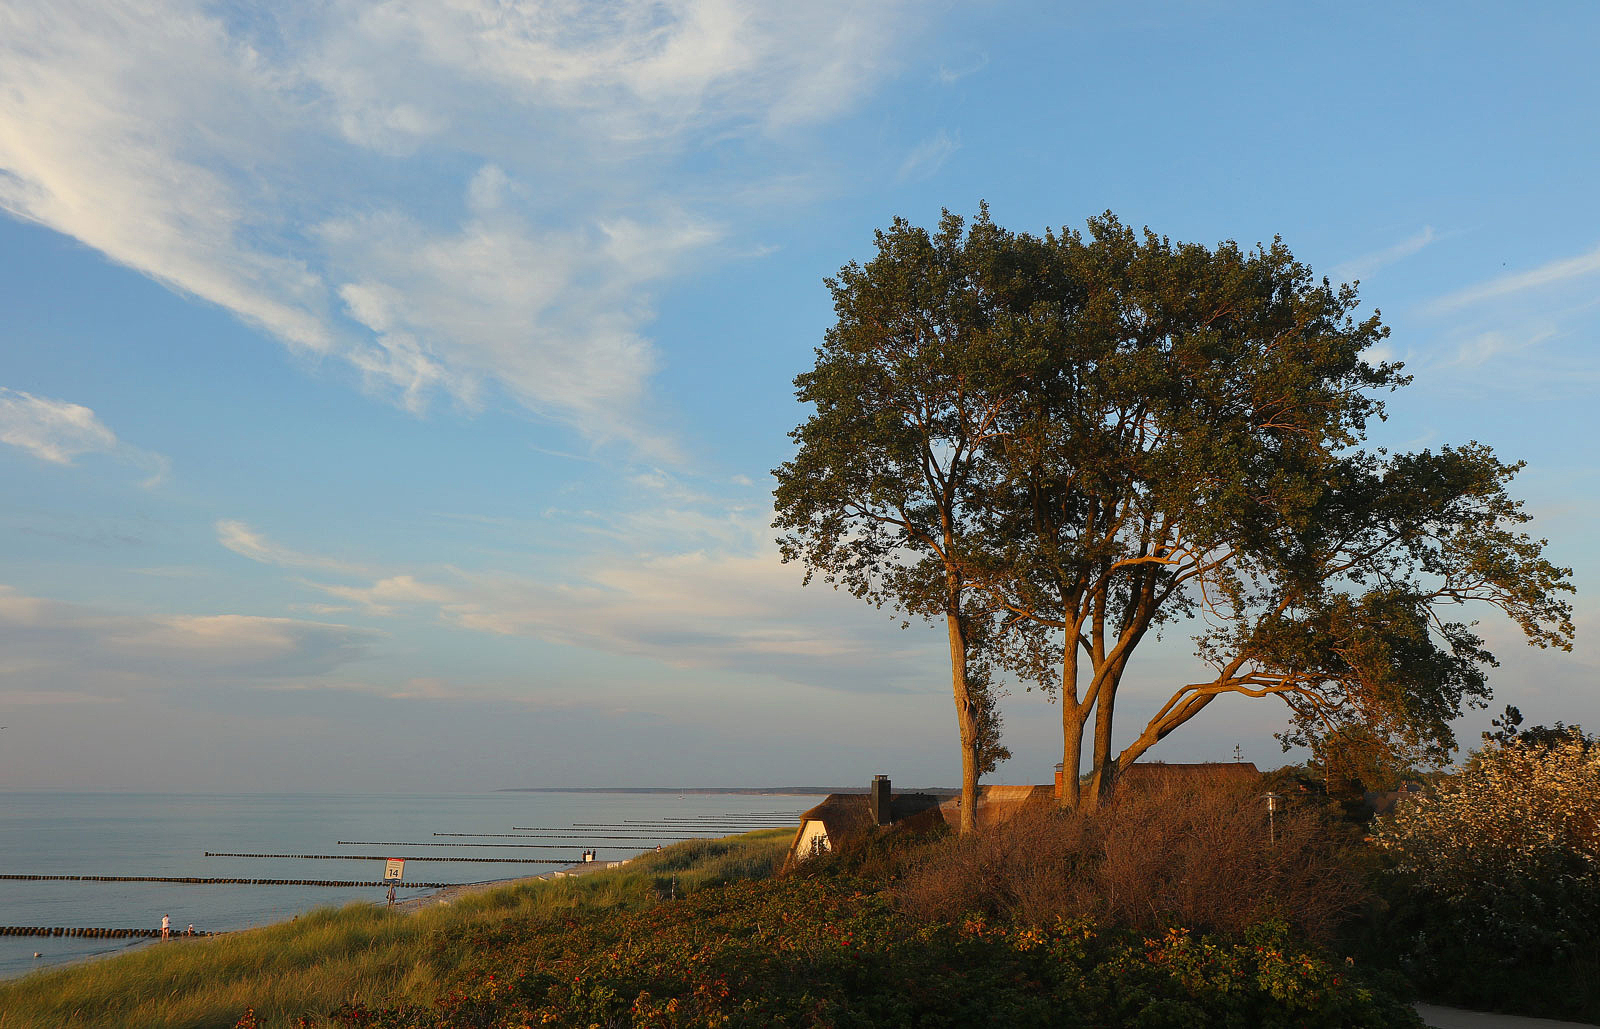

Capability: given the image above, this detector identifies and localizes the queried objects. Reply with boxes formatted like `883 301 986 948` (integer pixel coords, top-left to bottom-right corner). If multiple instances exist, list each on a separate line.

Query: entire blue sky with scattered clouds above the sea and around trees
0 0 1600 792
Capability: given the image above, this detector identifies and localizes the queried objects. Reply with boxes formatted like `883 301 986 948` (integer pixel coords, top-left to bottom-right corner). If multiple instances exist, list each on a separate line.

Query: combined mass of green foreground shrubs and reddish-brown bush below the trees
281 787 1421 1029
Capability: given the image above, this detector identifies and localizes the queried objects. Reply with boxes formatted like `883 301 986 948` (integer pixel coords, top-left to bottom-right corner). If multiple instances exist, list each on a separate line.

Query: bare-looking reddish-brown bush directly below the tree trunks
894 786 1363 939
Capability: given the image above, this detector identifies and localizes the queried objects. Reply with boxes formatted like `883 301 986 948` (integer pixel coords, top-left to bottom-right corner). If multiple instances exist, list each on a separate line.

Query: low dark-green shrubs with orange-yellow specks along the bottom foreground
305 877 1421 1029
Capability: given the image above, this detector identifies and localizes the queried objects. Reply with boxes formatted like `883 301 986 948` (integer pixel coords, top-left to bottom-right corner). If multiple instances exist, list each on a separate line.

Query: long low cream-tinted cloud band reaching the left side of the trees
233 512 942 690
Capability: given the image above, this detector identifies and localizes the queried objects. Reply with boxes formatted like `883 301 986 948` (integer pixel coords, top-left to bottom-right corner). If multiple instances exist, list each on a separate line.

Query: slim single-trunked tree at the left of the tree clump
773 214 1043 832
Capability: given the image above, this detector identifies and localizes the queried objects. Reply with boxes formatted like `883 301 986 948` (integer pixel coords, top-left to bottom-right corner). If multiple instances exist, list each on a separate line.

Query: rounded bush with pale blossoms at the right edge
1373 730 1600 1021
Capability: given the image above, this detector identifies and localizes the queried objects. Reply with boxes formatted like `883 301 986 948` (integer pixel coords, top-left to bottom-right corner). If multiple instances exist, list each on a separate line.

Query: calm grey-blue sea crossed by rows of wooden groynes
0 792 800 976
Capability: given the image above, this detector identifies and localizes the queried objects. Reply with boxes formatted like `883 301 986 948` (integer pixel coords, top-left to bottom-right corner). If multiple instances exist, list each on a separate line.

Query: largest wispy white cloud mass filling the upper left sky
0 0 906 442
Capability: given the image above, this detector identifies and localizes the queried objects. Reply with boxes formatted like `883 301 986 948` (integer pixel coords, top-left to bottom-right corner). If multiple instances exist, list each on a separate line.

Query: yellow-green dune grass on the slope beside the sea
0 829 794 1029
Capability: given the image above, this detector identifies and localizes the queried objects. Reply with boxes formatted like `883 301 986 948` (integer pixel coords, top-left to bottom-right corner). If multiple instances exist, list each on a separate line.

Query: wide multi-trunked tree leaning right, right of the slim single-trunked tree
962 214 1573 807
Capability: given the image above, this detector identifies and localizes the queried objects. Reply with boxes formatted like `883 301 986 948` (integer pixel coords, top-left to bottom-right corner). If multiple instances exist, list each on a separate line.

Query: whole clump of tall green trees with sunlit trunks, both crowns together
776 213 1573 819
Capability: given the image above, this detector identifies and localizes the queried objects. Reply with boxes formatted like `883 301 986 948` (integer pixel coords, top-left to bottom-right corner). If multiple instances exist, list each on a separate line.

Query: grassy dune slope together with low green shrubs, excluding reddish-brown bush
0 831 1419 1029
